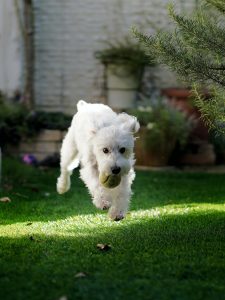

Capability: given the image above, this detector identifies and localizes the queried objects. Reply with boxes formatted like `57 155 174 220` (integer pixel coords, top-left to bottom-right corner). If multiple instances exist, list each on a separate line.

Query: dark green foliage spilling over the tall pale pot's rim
95 38 151 71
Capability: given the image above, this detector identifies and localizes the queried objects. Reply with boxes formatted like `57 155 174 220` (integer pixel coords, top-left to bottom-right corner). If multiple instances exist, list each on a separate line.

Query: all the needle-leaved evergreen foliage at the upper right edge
134 0 225 129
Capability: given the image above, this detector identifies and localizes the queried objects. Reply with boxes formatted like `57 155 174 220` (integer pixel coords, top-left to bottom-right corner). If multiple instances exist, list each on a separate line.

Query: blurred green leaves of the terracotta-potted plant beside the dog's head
131 98 193 151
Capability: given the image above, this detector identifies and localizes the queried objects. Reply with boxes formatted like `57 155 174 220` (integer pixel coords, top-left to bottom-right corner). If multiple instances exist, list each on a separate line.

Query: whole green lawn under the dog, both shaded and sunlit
0 159 225 300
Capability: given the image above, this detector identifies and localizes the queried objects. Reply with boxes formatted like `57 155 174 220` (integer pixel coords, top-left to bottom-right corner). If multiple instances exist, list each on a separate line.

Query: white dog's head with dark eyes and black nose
92 113 140 180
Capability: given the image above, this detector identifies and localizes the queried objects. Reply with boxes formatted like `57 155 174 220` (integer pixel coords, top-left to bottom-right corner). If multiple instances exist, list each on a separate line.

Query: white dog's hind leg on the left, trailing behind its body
56 127 79 194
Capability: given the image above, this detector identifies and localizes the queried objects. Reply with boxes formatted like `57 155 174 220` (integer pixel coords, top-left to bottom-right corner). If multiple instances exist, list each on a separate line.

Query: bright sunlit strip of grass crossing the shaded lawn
1 203 225 237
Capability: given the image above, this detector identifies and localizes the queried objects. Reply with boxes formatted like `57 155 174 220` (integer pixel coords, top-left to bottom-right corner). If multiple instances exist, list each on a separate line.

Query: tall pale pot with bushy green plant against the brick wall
95 38 153 109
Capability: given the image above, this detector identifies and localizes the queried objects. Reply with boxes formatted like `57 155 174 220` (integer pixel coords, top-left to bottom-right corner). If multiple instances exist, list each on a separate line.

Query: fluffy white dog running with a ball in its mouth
57 100 140 221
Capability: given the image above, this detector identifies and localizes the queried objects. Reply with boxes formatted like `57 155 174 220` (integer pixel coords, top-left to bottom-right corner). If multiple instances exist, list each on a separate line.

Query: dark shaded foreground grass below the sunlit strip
0 211 225 300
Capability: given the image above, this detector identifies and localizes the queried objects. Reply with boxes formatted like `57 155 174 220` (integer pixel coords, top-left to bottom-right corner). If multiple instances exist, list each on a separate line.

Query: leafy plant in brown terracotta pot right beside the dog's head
129 98 193 166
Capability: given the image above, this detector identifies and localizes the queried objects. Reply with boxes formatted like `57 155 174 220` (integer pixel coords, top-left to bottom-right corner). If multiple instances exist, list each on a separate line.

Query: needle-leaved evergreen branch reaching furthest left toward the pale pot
134 30 225 86
